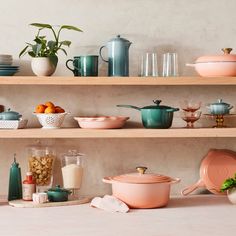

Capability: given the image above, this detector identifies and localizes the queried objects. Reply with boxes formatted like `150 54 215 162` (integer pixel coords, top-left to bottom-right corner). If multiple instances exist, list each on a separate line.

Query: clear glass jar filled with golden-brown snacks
28 145 56 192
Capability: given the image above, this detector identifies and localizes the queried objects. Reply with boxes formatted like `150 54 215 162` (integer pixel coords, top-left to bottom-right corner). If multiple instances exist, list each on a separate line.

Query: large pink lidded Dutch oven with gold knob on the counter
103 167 180 209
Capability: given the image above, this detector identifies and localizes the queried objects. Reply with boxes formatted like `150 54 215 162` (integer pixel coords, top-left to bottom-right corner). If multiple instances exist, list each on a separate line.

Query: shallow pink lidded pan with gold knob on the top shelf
186 48 236 77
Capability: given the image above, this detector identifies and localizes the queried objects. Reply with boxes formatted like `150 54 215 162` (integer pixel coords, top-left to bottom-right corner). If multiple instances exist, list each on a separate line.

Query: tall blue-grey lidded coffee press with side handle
99 35 131 76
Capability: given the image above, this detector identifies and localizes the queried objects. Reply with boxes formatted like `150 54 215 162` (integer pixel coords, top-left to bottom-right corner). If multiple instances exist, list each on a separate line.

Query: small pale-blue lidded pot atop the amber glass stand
207 99 233 115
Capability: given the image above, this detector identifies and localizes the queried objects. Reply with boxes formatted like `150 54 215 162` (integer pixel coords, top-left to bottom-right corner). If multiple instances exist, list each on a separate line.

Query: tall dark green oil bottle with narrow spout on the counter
8 154 22 201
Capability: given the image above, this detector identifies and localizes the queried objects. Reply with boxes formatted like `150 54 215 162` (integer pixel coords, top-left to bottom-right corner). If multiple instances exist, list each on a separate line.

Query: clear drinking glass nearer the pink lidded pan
162 53 179 77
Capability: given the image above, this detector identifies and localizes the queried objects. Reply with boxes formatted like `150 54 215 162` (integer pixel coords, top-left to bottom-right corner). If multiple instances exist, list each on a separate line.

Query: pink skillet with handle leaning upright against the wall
182 149 236 195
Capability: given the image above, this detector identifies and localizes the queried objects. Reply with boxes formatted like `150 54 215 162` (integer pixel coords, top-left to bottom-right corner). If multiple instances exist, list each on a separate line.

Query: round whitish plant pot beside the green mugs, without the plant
31 57 56 76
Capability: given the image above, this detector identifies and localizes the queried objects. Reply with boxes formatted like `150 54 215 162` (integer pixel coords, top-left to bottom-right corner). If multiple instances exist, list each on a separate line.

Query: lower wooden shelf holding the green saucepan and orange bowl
0 128 236 138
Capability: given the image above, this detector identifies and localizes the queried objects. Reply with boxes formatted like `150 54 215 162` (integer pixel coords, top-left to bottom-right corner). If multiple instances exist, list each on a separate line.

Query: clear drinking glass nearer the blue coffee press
141 53 158 77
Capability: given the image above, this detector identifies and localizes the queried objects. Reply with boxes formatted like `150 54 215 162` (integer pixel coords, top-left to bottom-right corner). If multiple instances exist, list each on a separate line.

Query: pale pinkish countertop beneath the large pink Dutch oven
0 195 236 236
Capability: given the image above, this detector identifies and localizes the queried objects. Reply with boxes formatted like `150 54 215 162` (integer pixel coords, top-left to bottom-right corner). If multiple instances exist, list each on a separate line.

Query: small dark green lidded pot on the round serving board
47 185 71 202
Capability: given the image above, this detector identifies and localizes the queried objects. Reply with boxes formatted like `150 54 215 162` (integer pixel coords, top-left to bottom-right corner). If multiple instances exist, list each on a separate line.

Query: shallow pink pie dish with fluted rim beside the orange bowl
74 116 129 129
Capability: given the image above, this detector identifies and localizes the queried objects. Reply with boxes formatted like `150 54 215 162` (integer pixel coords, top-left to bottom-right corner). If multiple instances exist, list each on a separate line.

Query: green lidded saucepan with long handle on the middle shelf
117 100 179 129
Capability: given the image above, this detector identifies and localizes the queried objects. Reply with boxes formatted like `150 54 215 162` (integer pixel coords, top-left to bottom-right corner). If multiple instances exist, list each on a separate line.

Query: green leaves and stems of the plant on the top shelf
19 23 82 66
